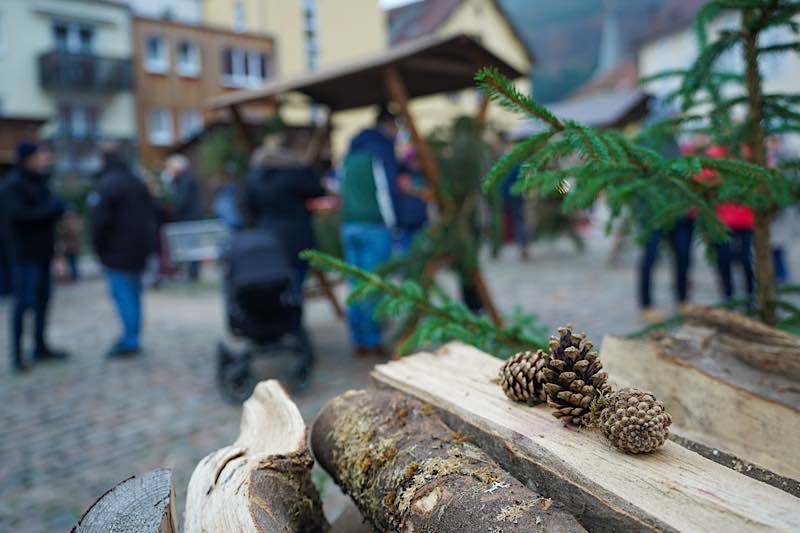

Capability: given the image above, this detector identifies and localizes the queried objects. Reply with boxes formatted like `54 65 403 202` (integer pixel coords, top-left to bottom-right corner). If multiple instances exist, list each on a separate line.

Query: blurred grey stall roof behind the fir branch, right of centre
510 89 649 140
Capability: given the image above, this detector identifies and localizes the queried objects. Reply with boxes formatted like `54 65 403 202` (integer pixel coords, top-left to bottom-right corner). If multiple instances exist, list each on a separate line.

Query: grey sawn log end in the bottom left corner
72 469 178 533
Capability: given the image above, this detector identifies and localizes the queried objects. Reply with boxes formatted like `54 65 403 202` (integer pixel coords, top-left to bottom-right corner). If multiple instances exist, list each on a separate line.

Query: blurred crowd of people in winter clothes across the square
0 100 797 372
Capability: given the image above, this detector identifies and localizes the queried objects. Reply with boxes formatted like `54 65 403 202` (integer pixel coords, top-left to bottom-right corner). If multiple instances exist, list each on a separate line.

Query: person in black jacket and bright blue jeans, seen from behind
89 146 156 357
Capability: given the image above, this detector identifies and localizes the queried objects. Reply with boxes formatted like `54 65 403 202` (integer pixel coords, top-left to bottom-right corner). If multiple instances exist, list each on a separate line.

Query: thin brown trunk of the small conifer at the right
742 9 775 324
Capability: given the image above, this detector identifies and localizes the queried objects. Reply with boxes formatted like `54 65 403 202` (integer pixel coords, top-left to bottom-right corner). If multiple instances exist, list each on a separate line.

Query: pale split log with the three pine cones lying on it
373 343 800 531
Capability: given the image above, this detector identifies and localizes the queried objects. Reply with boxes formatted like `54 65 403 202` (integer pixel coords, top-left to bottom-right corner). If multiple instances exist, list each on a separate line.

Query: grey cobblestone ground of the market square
0 221 800 533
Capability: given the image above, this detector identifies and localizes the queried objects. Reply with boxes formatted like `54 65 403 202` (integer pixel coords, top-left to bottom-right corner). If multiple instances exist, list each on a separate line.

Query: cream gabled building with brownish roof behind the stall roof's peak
387 0 533 132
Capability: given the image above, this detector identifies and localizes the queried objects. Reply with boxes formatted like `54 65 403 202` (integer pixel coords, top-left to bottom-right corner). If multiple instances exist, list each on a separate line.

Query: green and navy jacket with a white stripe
342 128 398 228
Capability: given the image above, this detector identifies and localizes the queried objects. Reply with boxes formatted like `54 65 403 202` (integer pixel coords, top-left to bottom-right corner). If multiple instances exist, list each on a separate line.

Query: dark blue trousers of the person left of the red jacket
639 217 694 307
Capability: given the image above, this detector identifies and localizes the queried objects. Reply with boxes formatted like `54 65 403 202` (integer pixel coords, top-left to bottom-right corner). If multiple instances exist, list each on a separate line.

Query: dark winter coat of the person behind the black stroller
245 164 325 264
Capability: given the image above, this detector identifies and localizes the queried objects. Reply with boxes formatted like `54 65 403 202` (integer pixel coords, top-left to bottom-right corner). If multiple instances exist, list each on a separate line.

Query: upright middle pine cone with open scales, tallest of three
541 325 611 426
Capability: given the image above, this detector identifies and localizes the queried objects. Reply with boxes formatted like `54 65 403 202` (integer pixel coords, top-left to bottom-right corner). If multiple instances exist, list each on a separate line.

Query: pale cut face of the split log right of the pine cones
600 337 800 479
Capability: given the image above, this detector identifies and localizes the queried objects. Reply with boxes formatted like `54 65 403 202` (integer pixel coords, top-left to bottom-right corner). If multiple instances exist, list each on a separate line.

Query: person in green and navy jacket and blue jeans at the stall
341 108 398 355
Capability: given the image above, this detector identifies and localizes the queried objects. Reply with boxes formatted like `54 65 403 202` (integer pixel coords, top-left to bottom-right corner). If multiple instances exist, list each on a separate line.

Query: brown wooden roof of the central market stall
208 34 522 111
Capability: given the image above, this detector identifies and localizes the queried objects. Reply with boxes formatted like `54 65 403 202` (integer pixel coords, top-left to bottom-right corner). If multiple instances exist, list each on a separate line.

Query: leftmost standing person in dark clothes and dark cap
3 142 67 372
